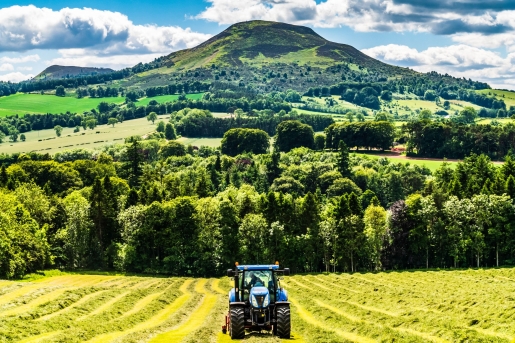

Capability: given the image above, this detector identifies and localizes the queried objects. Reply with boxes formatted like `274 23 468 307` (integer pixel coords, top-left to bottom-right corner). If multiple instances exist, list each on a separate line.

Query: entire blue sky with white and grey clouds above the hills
0 0 515 90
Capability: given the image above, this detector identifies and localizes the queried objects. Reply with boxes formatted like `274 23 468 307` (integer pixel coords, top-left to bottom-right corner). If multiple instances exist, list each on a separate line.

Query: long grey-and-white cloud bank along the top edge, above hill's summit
195 0 515 47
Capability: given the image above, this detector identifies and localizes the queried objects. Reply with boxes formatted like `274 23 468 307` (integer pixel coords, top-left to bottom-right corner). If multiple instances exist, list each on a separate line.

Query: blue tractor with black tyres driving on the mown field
222 262 291 339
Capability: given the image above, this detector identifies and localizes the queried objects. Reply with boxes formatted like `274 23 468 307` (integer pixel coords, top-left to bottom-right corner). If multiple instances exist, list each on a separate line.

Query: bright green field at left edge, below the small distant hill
0 93 125 117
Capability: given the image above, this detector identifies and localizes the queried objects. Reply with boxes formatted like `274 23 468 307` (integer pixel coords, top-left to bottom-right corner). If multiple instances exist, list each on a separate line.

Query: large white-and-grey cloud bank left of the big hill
0 5 210 55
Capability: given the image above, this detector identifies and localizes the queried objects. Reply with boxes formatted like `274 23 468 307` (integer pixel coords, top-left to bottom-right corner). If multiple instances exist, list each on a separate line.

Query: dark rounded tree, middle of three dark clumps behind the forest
275 120 315 152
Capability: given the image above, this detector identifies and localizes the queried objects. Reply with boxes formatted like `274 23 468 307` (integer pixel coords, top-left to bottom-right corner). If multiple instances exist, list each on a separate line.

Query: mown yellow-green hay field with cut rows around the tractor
0 269 515 342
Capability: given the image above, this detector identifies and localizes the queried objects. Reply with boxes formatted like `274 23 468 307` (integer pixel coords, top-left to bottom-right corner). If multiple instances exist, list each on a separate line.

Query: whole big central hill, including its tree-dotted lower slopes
123 21 421 90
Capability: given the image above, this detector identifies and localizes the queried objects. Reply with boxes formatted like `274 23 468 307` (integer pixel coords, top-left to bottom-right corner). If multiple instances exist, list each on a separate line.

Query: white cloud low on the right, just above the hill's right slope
362 44 515 89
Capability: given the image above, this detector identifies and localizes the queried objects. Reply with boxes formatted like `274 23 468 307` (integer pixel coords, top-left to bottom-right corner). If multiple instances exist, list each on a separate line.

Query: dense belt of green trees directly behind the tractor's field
0 121 515 278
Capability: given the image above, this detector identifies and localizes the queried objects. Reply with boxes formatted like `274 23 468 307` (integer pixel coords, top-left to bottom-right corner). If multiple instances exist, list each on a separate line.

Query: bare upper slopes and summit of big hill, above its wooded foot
165 21 403 73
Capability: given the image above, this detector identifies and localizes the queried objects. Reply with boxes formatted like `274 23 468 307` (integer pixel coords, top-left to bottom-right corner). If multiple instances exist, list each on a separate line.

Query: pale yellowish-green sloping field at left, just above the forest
0 116 168 154
